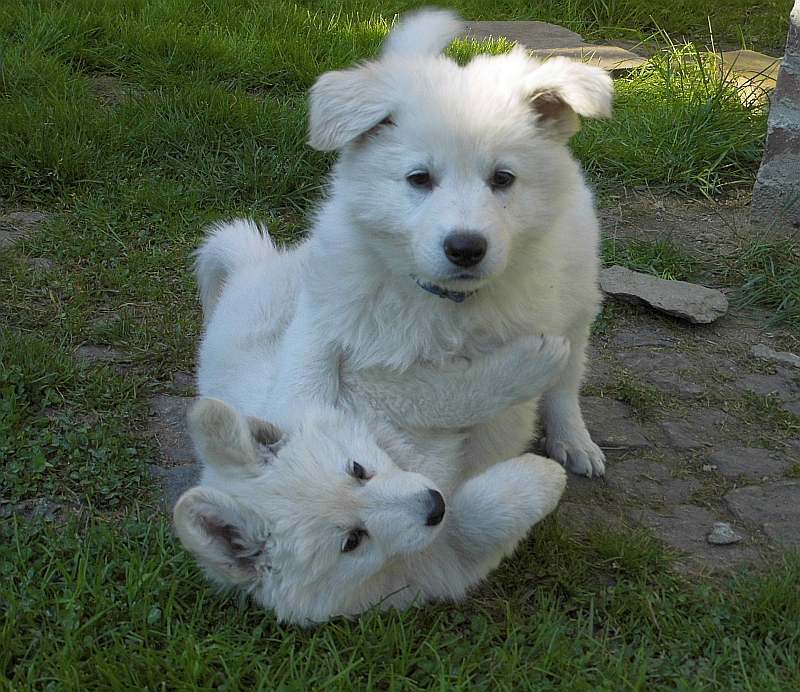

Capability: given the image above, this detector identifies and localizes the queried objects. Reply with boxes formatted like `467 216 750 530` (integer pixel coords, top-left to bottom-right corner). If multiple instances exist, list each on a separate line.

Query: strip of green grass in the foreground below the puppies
0 512 800 690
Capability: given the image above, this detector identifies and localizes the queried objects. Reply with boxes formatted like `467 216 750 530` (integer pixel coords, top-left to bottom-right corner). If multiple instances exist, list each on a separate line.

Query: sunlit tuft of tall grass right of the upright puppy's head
575 45 766 196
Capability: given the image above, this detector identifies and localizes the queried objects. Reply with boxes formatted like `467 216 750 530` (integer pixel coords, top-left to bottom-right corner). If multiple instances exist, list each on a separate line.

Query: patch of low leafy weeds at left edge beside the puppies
0 332 147 508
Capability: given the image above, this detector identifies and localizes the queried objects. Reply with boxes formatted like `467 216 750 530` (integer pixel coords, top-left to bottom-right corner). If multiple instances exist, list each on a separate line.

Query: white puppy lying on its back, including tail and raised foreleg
179 215 568 624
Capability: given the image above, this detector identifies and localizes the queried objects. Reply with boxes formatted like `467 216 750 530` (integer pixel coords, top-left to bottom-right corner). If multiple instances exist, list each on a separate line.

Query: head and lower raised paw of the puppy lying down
174 398 566 625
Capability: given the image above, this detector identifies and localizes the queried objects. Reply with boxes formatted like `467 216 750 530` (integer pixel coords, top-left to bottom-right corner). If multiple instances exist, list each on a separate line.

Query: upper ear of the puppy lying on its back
188 397 282 475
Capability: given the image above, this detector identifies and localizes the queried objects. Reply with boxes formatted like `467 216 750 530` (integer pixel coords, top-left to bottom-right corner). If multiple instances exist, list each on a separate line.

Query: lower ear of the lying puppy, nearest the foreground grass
172 487 270 586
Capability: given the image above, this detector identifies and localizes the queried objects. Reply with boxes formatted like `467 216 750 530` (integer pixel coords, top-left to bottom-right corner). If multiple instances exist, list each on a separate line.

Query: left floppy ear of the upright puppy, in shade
308 63 394 151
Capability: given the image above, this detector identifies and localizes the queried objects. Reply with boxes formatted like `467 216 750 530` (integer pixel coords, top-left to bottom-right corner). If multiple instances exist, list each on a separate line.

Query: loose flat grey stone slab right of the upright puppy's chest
600 265 728 324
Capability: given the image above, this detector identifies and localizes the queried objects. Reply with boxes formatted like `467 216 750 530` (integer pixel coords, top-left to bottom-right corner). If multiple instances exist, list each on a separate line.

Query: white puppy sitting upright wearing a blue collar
278 11 613 476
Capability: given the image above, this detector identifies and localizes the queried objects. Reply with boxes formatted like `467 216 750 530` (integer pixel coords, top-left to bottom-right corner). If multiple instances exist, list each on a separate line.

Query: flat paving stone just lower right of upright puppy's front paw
606 459 700 504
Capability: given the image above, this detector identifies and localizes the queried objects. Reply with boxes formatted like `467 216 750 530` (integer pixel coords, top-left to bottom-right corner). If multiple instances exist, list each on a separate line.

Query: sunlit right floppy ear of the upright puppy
524 57 614 141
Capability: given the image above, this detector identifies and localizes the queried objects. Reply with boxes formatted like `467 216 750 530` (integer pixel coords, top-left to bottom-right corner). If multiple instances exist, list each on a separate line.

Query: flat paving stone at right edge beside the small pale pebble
725 480 800 548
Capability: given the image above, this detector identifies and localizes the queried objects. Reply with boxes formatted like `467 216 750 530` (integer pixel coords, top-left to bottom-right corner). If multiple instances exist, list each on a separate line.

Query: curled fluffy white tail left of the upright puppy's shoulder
194 219 278 319
